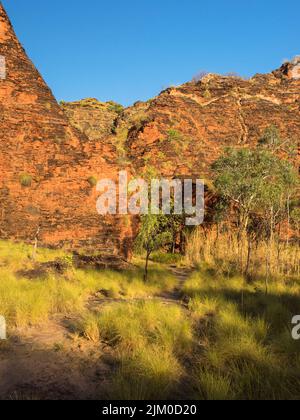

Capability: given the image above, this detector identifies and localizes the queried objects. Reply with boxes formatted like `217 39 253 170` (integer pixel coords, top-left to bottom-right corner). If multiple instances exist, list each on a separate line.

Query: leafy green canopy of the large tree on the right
212 148 298 233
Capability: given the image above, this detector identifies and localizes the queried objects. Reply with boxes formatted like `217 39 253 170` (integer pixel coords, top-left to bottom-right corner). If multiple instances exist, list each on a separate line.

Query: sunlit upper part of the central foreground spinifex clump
76 301 192 354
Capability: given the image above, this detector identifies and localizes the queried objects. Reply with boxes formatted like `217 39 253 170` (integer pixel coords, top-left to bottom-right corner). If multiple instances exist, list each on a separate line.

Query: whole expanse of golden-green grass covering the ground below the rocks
0 236 300 400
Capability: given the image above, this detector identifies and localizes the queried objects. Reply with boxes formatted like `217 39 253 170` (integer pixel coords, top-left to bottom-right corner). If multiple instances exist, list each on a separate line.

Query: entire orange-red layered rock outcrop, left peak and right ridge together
0 5 300 255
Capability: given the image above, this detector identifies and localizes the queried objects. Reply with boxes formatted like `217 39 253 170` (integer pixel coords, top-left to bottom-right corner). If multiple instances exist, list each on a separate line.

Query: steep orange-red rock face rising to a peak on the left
0 5 131 254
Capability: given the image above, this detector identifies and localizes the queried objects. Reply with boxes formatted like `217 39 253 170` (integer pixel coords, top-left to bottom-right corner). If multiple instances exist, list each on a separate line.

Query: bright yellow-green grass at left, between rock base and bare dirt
0 241 176 328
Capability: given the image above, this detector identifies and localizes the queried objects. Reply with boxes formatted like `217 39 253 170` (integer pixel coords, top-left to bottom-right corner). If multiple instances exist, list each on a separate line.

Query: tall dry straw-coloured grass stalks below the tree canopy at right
185 228 300 277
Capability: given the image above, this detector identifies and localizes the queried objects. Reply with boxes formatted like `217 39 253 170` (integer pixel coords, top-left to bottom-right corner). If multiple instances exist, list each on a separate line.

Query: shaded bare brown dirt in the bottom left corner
0 330 110 400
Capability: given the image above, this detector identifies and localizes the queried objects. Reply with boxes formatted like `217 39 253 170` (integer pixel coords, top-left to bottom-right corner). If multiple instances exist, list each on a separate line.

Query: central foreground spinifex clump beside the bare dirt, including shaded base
80 302 193 400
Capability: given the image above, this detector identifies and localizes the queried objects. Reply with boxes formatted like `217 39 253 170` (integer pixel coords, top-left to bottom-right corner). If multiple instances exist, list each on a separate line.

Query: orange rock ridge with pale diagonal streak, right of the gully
123 72 300 178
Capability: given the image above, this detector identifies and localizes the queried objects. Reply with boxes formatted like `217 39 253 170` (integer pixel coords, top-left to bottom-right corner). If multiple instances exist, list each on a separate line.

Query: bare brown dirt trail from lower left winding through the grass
0 266 191 400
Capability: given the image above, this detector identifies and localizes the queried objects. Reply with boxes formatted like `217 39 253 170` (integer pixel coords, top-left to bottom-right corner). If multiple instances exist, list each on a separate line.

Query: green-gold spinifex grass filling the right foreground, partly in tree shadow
185 267 300 399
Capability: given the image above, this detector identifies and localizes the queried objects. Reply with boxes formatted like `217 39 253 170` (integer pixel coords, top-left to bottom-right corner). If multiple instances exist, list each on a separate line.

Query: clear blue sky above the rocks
2 0 300 105
